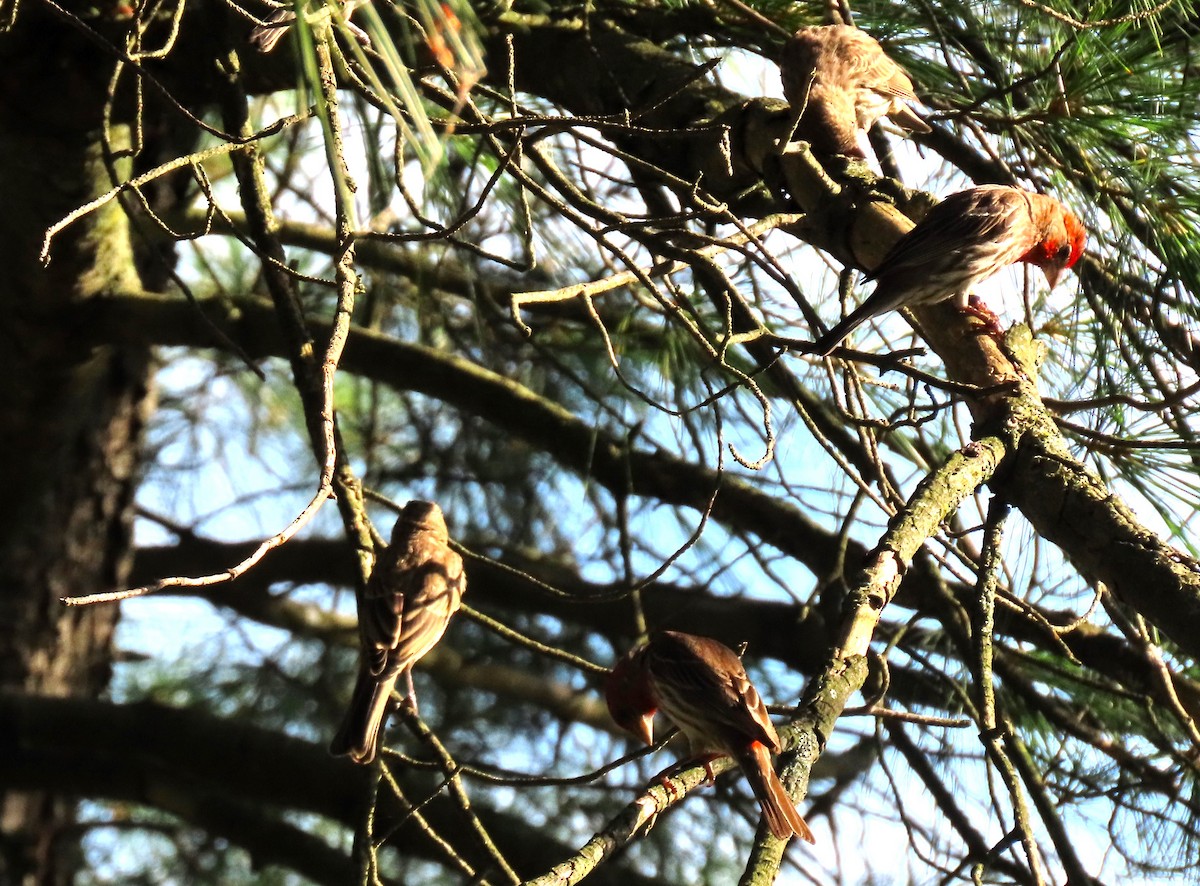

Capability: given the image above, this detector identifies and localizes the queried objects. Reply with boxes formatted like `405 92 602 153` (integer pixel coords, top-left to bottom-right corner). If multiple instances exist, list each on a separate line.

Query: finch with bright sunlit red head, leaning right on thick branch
815 185 1086 357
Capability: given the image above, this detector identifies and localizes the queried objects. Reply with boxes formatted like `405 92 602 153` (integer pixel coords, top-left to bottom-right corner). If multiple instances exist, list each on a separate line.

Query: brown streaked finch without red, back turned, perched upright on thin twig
329 501 467 764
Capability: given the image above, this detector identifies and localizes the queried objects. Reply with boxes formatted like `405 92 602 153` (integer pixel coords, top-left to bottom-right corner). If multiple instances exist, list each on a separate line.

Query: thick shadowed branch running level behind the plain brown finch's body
131 528 1200 726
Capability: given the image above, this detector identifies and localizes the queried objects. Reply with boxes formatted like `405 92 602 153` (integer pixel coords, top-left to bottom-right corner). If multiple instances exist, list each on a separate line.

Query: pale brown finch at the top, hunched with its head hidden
779 25 929 158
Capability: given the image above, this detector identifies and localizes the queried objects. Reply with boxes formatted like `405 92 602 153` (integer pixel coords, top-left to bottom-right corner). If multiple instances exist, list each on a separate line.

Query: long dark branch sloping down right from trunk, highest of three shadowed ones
90 286 838 575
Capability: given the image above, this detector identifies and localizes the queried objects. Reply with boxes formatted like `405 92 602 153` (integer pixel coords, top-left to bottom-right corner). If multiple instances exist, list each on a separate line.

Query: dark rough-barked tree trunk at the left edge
0 10 151 885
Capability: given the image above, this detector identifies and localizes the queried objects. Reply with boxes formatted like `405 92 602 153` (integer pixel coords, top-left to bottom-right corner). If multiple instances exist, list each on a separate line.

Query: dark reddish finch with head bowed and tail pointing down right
605 630 815 843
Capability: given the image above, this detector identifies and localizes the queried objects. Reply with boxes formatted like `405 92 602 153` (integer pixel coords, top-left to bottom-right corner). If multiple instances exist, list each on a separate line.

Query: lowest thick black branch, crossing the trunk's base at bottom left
0 695 653 886
